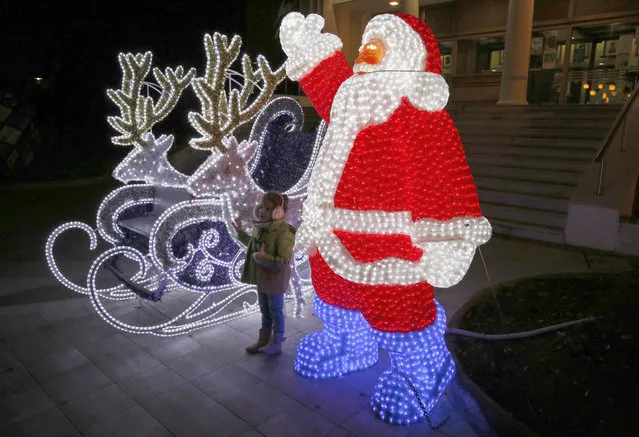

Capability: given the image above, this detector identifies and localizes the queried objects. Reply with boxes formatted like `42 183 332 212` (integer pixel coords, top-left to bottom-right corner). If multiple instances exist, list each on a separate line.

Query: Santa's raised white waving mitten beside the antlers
280 12 342 80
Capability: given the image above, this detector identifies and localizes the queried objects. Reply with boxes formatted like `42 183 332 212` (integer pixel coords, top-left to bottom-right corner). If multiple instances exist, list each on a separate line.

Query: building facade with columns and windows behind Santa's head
318 0 639 104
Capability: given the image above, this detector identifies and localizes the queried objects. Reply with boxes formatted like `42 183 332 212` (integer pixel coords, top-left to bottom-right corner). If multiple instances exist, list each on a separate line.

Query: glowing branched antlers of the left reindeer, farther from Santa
107 52 195 147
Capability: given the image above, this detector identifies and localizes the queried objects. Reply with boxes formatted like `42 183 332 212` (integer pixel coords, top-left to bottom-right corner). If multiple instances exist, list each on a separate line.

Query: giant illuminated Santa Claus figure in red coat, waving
280 12 491 423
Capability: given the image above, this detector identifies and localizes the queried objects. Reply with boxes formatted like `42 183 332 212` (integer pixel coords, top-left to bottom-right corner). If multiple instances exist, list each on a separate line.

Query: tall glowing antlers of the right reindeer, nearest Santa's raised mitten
189 32 286 152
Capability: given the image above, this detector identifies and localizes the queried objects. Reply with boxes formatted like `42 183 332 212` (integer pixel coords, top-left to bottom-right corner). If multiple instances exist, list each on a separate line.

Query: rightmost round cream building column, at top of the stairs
497 0 535 105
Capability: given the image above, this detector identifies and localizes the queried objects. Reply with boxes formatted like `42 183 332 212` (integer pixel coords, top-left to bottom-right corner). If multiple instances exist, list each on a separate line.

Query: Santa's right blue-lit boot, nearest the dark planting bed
371 301 455 424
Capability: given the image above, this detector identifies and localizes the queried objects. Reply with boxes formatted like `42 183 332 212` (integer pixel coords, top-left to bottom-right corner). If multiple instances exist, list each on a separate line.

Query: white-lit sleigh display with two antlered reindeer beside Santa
46 34 326 336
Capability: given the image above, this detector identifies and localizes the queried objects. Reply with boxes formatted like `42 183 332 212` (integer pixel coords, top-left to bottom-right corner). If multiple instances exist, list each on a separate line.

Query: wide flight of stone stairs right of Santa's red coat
449 104 621 243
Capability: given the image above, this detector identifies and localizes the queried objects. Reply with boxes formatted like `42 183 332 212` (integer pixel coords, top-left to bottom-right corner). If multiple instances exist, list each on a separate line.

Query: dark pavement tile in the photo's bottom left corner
0 408 80 437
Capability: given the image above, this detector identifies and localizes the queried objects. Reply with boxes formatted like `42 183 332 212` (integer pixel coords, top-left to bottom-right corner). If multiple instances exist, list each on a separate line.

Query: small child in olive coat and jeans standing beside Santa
233 191 295 355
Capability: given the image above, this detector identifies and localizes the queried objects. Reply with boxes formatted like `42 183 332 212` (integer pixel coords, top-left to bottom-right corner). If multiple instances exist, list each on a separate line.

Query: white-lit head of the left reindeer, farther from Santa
113 132 188 187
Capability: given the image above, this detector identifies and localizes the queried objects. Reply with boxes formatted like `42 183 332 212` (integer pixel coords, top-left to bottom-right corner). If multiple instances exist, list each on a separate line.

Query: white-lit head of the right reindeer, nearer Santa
187 136 259 199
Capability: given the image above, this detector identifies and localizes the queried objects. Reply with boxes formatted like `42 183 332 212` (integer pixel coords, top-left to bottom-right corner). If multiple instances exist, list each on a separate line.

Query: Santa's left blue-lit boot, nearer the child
294 296 379 379
